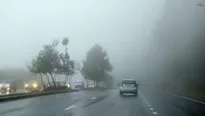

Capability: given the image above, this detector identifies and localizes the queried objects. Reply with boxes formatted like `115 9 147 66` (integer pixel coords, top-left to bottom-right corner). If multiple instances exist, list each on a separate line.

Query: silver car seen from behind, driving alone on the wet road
120 79 138 96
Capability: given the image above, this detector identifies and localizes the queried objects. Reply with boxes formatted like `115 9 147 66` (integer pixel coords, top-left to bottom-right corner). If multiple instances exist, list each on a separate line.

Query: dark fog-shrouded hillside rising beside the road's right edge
143 0 205 91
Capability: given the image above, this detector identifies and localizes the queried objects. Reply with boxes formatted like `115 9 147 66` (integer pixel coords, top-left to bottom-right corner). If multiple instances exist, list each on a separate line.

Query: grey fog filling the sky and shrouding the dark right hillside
0 0 205 90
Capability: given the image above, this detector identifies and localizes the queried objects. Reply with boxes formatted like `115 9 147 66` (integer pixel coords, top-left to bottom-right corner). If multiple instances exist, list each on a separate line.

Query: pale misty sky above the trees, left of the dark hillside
0 0 164 73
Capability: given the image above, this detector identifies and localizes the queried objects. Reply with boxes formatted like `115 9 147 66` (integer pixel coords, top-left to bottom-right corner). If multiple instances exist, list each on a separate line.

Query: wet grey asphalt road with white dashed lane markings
0 87 205 116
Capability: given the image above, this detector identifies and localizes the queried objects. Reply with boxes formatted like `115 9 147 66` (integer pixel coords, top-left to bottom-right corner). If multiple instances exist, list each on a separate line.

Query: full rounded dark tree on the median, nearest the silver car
82 44 113 85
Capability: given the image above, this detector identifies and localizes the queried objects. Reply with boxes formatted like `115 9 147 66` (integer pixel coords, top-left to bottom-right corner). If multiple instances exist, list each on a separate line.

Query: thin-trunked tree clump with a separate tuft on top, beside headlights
27 38 74 88
